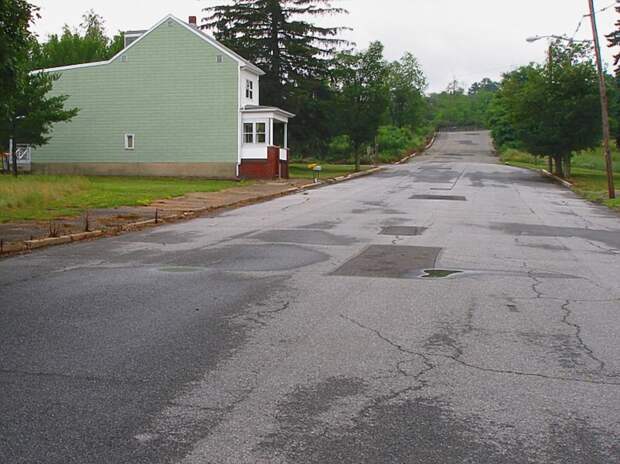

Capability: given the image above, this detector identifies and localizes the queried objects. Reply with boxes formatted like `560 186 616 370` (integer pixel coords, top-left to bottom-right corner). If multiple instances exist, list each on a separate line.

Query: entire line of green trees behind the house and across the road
0 0 620 179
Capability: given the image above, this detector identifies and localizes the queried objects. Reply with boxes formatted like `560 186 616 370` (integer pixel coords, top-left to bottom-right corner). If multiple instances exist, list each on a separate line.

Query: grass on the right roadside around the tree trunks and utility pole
501 150 620 210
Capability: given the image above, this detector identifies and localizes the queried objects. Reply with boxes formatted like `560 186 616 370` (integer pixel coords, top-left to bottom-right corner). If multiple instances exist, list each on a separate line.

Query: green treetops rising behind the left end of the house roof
34 10 124 69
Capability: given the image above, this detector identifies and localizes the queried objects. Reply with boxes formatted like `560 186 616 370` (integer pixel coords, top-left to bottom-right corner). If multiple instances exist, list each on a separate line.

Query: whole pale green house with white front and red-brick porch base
32 15 294 178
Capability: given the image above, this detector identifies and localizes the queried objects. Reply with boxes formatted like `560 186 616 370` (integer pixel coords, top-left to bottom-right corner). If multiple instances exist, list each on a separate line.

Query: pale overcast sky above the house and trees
31 0 620 91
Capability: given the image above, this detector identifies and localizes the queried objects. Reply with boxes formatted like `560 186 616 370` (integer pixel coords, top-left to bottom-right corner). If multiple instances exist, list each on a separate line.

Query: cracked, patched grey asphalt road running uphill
0 132 620 464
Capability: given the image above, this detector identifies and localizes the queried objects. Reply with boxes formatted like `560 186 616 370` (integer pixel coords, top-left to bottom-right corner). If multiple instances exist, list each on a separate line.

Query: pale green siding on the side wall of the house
33 21 239 163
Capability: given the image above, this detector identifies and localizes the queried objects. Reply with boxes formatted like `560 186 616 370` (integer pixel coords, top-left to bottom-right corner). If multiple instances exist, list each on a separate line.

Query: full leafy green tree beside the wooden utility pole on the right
491 42 601 175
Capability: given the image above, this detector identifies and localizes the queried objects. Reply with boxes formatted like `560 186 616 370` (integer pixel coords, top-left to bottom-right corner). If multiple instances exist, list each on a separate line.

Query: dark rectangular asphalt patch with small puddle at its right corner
332 245 442 279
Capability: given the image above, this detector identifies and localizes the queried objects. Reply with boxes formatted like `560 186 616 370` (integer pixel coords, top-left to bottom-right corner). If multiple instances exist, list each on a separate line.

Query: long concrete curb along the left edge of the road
0 166 384 257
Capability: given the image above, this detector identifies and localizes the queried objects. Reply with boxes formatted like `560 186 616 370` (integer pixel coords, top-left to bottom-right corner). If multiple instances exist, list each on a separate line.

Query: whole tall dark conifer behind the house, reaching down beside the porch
203 0 347 153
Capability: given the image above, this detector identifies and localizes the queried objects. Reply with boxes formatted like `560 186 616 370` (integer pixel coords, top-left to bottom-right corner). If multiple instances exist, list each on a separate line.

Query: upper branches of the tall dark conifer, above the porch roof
202 0 347 109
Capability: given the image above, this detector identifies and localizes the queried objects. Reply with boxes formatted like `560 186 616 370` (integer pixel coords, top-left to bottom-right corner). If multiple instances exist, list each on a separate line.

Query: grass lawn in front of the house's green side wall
0 175 243 222
